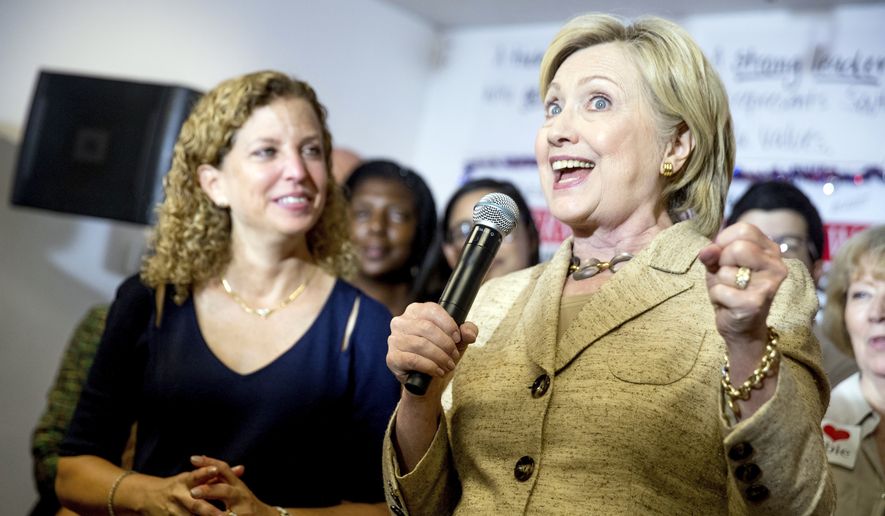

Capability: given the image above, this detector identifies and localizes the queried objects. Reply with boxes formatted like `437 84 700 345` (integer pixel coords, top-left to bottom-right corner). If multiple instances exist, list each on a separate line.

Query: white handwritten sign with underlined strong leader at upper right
686 6 885 172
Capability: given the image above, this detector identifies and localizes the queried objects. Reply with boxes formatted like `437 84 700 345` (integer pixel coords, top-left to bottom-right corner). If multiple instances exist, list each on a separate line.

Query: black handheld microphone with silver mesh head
405 193 519 396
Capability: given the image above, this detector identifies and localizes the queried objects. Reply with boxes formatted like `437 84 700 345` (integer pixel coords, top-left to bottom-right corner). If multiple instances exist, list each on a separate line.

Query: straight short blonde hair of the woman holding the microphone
540 14 735 237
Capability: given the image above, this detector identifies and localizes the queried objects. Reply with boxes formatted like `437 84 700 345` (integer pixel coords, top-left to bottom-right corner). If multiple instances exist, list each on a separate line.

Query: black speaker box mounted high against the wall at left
12 71 201 224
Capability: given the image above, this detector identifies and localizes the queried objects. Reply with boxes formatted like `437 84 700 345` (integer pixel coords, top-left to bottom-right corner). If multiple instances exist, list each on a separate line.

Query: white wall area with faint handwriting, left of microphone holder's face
406 24 559 209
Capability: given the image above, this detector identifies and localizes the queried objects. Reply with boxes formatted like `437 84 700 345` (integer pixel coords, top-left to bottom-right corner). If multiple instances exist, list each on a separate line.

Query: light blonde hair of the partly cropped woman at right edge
823 225 885 356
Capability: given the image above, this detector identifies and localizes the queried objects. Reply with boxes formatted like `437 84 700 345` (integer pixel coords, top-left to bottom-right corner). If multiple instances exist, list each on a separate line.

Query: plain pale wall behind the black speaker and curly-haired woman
0 0 436 514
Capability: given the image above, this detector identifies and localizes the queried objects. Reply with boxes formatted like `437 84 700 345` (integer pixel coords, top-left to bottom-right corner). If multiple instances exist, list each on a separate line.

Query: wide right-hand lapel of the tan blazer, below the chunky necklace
545 222 709 373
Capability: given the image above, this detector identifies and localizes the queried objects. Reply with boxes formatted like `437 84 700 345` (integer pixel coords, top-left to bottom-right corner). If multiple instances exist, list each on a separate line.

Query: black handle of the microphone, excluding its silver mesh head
403 225 504 396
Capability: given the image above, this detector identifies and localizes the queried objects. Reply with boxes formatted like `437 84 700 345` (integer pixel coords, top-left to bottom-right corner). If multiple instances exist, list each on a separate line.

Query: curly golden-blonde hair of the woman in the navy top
141 71 355 303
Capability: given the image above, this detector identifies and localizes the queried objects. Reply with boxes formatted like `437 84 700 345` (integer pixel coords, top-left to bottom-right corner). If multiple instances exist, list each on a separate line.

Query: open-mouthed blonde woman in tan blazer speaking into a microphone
384 15 833 515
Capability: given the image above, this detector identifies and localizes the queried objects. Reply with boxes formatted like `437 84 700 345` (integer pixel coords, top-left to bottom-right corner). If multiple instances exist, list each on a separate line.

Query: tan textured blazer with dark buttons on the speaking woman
384 222 833 515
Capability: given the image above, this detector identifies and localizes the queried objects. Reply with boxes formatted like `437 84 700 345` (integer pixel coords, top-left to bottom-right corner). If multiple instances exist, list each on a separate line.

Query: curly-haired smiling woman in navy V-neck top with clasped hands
56 72 398 515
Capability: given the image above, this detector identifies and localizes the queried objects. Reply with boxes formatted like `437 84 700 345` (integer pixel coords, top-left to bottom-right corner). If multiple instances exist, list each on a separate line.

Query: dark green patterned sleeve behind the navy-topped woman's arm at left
31 305 108 498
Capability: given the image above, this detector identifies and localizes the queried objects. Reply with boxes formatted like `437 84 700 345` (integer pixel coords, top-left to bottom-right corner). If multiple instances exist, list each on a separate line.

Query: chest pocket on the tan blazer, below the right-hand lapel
608 328 710 385
